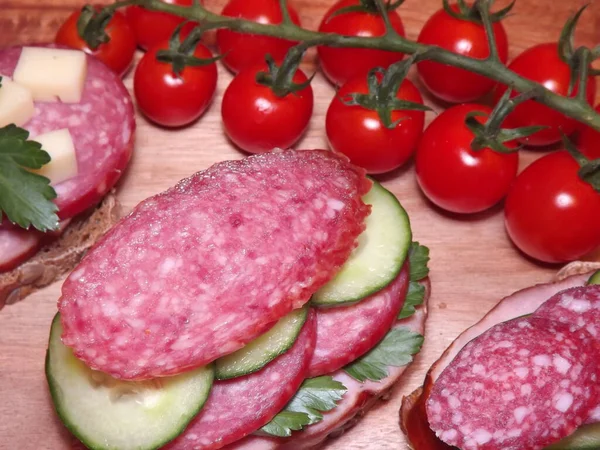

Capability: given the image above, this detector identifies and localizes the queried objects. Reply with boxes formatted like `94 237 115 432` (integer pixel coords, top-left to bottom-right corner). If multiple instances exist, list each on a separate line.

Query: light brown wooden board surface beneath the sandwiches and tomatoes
0 0 600 450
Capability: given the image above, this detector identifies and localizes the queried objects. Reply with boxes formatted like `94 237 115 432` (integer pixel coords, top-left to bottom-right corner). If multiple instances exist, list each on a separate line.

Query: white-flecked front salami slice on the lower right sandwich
426 317 600 450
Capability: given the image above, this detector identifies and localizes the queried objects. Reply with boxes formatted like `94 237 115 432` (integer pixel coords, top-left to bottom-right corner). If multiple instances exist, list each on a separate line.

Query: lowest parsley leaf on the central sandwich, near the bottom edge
261 376 346 437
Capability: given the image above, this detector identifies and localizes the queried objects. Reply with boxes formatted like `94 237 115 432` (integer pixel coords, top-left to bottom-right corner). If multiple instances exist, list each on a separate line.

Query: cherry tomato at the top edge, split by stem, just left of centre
217 0 300 73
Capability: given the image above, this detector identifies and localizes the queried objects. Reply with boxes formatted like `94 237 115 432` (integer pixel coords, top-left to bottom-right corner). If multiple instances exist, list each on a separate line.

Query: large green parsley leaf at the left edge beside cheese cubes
0 124 58 231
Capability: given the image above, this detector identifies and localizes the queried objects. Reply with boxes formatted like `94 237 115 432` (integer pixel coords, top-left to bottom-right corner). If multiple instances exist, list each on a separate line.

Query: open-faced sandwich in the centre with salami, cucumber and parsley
46 150 429 450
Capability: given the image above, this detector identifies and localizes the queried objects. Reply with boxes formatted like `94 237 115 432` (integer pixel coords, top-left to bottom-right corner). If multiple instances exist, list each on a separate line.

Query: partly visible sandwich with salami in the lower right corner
400 270 600 450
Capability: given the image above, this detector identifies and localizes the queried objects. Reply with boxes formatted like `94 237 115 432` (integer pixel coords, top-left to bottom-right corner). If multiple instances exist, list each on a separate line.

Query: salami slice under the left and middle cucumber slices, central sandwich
164 312 316 450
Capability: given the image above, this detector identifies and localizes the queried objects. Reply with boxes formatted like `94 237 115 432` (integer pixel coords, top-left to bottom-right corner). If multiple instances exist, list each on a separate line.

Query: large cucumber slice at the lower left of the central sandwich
46 314 213 450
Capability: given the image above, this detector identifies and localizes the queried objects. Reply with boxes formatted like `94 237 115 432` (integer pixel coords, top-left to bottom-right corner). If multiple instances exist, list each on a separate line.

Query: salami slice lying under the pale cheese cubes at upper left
0 45 135 219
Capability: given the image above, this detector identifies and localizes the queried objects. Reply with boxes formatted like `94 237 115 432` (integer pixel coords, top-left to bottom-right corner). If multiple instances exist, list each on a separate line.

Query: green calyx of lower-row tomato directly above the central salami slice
256 42 315 98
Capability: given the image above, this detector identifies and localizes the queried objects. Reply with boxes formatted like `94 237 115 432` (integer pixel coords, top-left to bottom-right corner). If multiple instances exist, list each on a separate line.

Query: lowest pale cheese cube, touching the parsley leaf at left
32 128 77 185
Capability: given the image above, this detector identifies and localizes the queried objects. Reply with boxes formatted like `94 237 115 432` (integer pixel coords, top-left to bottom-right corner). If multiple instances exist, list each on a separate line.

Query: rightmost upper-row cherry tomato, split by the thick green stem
494 43 596 146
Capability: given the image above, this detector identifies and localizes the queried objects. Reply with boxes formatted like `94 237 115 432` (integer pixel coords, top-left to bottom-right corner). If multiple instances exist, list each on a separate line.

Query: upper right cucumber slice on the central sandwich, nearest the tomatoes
311 181 412 307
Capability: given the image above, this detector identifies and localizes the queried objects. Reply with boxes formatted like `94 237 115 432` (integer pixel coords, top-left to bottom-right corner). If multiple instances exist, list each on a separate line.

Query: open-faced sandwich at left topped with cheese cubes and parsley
0 45 135 309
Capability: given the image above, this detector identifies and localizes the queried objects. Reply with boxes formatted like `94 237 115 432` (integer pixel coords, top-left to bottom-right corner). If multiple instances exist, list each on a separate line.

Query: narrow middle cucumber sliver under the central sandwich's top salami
215 307 308 380
